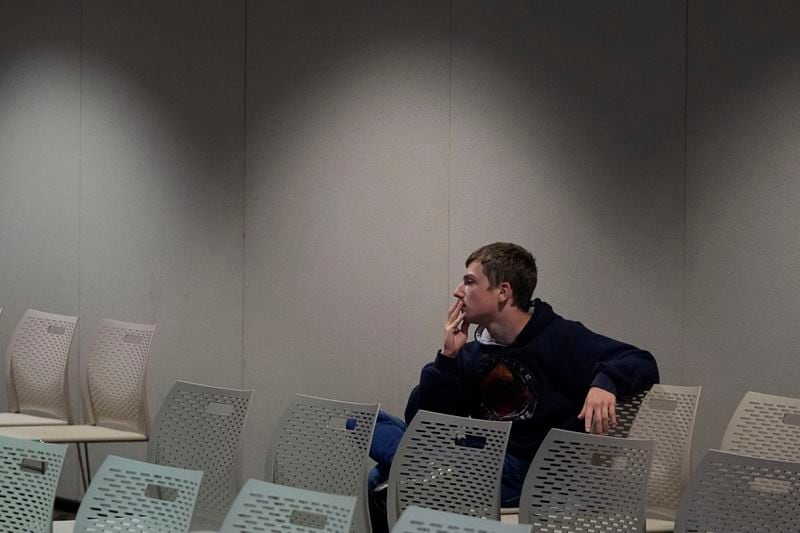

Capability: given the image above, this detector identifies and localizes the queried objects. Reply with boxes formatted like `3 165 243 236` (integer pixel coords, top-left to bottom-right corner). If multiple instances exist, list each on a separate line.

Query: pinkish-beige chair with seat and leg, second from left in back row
0 319 156 489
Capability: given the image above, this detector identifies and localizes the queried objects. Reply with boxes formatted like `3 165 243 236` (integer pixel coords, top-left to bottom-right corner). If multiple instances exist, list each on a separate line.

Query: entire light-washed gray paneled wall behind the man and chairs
6 0 800 495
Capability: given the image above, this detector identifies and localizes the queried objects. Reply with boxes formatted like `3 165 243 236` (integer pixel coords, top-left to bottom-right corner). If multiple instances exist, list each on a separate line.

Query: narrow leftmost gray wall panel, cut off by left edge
0 1 82 489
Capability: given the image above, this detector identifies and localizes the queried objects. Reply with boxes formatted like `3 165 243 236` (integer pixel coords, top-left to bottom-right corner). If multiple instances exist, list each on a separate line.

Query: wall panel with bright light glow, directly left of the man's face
245 1 449 475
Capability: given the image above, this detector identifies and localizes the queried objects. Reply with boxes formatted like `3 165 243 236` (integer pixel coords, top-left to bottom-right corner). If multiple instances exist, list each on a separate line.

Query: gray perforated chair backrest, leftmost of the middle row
148 381 253 527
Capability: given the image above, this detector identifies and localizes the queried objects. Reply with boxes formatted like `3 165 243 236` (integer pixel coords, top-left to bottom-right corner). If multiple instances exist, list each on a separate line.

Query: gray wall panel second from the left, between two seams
80 0 245 490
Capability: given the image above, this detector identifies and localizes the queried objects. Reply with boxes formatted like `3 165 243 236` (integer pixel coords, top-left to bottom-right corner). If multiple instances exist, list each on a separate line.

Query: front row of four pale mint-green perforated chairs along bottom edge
0 437 530 533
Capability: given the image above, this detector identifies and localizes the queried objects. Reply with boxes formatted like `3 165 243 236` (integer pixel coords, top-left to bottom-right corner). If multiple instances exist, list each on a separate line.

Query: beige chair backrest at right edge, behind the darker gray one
722 386 800 462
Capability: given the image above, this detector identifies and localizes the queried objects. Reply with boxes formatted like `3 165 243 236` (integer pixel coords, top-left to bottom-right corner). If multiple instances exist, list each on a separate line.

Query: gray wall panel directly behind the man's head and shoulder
449 1 685 383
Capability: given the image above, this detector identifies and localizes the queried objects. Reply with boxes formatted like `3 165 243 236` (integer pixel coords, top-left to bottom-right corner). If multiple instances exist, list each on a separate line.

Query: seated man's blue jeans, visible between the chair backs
369 411 531 504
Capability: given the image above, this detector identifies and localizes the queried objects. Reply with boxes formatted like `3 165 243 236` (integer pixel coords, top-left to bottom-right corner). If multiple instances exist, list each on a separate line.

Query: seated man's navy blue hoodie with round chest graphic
406 298 658 460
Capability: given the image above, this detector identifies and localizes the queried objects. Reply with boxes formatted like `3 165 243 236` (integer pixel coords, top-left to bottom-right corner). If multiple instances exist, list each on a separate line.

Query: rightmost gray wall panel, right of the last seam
685 1 800 462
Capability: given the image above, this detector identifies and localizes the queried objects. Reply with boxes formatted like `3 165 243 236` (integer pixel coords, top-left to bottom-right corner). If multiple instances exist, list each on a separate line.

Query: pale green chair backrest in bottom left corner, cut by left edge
0 437 67 533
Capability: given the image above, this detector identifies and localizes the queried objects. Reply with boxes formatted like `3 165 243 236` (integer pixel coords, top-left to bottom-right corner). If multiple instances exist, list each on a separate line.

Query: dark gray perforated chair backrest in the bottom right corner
674 450 800 533
